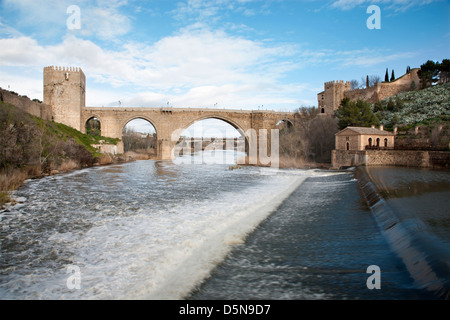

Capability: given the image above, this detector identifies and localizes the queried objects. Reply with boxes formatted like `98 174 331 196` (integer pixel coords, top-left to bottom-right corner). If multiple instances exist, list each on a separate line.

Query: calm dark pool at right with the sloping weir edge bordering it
355 167 450 299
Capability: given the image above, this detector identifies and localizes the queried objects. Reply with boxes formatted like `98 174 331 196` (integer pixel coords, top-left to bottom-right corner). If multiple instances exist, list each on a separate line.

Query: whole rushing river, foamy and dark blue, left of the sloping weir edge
0 151 446 299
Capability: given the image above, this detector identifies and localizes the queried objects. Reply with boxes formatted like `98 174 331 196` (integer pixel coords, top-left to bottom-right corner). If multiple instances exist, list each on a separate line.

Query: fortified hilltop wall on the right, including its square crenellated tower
317 68 420 115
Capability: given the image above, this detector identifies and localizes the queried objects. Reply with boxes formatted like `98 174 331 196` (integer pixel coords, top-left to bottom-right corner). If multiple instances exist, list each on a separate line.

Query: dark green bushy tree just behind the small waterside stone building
336 98 379 129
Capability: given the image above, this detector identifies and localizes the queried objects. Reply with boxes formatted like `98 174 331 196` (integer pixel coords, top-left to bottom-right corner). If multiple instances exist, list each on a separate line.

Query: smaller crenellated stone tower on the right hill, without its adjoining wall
317 80 351 115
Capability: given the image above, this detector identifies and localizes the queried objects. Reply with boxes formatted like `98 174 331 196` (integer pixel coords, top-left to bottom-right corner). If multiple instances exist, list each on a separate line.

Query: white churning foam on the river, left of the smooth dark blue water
0 155 314 299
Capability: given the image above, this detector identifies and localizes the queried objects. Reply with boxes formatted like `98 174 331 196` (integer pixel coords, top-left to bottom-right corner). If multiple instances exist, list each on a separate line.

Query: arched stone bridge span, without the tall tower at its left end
81 107 295 160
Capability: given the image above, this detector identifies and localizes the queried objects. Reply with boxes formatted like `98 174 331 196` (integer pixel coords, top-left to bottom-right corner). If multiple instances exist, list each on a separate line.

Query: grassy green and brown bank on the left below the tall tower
0 101 117 207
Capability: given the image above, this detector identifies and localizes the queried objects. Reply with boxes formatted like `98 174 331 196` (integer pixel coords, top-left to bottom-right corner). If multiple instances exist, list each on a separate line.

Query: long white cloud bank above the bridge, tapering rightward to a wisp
0 25 413 109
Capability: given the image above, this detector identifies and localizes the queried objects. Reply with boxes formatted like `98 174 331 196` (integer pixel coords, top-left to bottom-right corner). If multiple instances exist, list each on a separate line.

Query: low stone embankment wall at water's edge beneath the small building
331 150 450 168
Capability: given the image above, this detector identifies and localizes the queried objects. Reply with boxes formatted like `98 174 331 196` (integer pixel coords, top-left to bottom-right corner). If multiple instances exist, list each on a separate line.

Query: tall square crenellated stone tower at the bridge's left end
44 66 86 131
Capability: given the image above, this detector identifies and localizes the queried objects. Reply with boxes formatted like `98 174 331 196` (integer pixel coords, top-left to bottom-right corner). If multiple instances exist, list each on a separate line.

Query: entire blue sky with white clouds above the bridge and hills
0 0 450 134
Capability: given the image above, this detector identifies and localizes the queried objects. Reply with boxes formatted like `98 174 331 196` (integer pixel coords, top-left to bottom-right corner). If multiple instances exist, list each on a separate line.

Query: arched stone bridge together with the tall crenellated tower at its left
44 66 296 164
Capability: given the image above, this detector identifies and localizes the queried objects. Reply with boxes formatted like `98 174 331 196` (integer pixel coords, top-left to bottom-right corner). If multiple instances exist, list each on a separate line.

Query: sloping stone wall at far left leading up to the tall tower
0 88 52 121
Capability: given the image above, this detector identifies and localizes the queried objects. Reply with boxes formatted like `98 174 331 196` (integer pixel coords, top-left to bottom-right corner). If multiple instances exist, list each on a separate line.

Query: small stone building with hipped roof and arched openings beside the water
335 126 394 150
